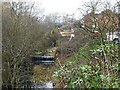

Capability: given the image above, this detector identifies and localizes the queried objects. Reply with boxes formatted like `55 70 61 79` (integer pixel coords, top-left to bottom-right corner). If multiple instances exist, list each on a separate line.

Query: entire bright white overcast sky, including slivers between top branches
3 0 119 17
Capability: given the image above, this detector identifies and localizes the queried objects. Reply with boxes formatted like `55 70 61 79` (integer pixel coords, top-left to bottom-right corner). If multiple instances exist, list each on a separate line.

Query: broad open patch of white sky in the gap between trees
36 0 82 13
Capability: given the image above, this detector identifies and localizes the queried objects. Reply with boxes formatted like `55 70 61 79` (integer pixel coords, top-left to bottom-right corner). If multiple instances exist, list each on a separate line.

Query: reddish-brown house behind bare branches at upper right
83 9 119 32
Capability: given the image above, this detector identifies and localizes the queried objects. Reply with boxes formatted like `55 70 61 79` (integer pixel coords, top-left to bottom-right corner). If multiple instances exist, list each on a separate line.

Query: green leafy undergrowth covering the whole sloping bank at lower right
53 41 120 88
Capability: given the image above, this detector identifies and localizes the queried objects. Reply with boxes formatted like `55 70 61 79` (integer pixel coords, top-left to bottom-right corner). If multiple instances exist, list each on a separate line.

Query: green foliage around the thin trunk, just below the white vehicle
90 42 118 61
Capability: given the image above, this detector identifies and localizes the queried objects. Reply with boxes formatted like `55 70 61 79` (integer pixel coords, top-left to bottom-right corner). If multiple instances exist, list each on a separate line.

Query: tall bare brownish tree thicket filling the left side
2 2 48 88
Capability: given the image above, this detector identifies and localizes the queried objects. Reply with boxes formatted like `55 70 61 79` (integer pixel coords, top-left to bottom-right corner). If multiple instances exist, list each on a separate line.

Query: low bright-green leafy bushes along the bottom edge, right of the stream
53 64 119 88
